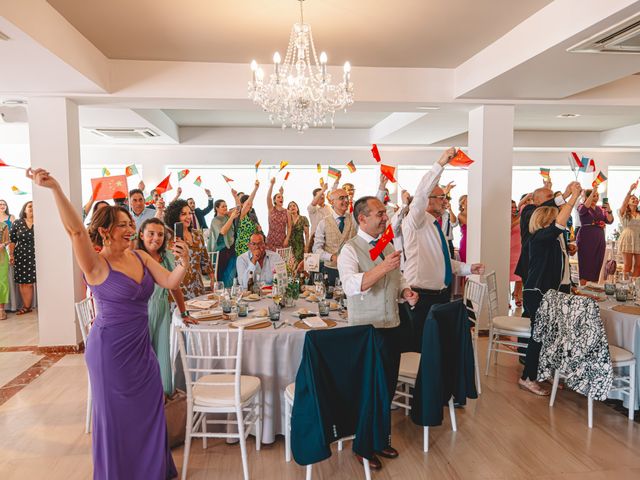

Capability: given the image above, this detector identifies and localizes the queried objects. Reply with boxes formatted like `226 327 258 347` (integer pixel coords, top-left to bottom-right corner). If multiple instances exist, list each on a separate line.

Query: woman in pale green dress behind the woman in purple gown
138 218 198 395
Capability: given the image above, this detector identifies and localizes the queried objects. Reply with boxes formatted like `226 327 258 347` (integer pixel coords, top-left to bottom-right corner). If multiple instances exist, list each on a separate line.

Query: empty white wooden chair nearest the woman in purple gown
175 327 262 480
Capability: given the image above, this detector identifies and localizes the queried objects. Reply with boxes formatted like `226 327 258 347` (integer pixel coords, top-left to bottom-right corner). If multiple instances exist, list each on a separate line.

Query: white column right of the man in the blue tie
467 105 514 322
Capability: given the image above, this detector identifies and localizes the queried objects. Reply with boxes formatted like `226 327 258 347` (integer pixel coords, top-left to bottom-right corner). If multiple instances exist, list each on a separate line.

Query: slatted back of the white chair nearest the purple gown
174 326 244 405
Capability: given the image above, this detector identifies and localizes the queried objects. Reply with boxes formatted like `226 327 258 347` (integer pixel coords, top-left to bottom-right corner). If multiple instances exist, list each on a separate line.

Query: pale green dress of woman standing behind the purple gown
148 252 175 395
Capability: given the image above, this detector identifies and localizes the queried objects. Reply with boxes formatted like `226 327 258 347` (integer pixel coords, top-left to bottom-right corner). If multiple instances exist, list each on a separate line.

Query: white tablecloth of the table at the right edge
599 300 640 410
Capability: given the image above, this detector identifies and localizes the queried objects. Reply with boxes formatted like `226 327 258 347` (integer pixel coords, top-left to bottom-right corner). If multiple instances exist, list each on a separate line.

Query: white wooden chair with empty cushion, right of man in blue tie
484 272 531 375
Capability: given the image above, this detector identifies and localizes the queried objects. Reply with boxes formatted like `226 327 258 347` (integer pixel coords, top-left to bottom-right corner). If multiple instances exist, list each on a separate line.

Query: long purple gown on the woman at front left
85 253 177 480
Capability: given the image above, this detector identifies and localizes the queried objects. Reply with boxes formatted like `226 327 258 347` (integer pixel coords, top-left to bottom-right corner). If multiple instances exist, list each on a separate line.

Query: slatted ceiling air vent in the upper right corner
568 15 640 53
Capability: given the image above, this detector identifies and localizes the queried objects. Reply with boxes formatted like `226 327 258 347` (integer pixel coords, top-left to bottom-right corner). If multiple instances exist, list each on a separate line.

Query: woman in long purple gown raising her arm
27 169 188 480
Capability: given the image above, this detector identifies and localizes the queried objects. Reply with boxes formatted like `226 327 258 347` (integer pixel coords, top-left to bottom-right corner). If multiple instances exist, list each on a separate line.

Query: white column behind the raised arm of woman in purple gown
29 98 85 347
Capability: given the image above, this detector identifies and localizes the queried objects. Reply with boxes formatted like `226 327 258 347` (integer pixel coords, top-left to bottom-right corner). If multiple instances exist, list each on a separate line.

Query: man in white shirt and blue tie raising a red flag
402 148 484 344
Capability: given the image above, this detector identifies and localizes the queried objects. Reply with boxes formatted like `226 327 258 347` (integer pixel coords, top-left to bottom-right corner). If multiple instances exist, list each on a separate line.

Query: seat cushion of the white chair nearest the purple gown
193 375 260 407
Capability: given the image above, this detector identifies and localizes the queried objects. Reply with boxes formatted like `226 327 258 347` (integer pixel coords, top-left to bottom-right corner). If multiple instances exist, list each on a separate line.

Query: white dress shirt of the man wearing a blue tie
402 162 471 290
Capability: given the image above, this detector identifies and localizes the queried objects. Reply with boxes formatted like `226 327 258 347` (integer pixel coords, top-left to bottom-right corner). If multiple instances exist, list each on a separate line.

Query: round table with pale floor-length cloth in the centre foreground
171 295 347 443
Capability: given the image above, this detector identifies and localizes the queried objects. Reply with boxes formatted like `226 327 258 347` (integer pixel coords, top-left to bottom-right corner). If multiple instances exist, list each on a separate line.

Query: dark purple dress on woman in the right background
576 204 610 282
